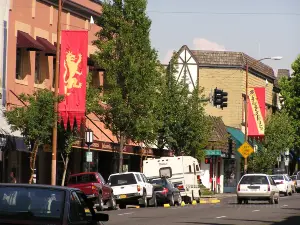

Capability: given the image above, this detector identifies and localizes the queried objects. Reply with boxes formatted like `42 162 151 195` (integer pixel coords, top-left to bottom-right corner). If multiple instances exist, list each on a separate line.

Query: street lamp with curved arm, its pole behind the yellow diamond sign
244 56 282 174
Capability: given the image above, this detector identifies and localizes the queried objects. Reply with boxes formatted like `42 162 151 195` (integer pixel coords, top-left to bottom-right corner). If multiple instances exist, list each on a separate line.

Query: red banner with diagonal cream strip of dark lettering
248 87 266 138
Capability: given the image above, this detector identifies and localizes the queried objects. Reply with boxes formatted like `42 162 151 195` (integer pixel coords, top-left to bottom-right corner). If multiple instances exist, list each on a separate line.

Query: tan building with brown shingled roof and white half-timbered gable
172 45 279 192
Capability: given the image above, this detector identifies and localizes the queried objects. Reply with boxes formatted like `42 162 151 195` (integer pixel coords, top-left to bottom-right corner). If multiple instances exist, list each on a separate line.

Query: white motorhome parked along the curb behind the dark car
143 156 201 203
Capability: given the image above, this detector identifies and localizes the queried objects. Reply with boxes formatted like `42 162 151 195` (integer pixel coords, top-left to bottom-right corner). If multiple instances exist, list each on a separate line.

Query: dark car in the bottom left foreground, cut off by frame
0 184 108 225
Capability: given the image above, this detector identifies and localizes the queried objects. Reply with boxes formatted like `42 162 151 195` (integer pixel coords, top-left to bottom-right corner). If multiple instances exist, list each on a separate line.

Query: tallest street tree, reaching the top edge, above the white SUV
93 0 159 172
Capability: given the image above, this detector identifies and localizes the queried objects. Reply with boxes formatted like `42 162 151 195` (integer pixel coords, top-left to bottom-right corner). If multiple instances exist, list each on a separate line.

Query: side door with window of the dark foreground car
68 191 92 225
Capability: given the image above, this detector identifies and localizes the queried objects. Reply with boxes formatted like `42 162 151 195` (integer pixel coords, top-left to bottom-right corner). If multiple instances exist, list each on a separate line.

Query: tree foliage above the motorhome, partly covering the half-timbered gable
156 54 212 158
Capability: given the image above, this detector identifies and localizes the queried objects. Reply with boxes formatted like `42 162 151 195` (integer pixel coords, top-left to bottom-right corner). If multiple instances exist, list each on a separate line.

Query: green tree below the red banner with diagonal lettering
249 111 295 173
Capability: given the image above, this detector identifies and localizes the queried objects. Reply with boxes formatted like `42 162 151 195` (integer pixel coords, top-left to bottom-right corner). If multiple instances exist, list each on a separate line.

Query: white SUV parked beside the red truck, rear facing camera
108 172 157 209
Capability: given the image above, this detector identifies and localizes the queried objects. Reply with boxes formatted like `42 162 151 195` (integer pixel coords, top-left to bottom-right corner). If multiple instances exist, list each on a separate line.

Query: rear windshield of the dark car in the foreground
0 186 65 220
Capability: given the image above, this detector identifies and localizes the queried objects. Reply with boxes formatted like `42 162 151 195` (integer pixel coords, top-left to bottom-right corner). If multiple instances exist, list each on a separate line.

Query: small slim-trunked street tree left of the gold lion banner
5 89 62 184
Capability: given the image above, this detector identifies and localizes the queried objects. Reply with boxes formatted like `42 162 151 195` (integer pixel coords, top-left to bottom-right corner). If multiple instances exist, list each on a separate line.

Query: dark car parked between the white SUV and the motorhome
149 177 182 206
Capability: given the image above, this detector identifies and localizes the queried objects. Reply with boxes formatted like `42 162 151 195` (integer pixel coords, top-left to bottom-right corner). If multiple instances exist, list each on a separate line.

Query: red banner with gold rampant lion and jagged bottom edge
58 30 88 129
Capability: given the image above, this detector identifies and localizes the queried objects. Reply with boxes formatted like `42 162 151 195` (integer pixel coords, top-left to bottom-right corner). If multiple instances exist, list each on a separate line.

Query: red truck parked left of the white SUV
67 172 117 211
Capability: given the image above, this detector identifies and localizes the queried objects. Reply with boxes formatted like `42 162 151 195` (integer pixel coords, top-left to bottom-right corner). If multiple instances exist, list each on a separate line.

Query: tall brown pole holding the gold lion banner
51 0 62 185
